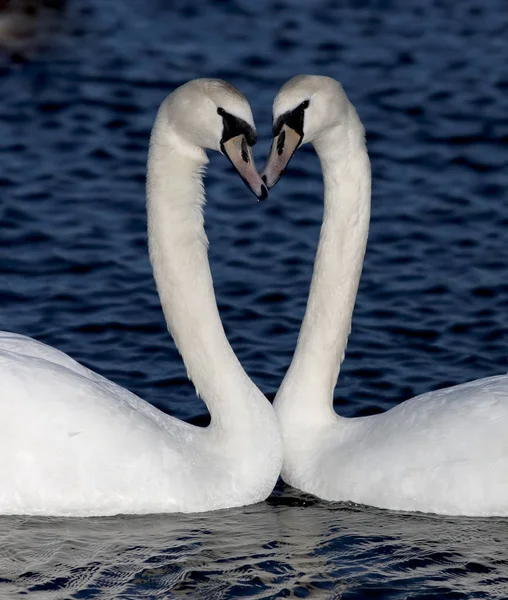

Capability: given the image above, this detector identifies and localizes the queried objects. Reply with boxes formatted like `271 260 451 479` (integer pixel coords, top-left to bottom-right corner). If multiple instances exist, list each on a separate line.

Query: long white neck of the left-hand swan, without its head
147 109 262 427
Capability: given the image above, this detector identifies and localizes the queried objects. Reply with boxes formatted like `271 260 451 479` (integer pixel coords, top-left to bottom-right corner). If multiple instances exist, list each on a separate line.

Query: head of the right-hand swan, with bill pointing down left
262 75 354 189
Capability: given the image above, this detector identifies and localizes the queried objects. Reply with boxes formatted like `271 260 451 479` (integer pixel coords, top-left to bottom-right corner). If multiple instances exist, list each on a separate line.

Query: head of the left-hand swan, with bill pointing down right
161 79 268 200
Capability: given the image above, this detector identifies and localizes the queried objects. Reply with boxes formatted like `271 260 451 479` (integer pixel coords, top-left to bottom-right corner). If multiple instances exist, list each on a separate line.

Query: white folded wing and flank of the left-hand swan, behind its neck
0 336 207 516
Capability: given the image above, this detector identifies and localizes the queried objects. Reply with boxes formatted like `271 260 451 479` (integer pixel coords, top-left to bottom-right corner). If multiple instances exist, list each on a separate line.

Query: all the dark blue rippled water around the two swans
0 0 508 600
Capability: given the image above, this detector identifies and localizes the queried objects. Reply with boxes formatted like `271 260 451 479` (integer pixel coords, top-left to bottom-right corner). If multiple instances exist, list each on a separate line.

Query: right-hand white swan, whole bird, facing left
264 76 508 516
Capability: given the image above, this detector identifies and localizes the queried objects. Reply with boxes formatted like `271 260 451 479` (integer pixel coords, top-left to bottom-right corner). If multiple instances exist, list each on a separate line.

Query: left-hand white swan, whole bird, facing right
0 79 282 516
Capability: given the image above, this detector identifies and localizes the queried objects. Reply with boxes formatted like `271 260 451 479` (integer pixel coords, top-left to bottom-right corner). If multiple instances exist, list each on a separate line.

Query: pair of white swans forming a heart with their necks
0 76 508 516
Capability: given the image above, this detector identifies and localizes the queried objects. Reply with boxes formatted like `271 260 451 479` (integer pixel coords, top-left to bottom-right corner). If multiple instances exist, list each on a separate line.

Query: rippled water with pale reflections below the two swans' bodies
0 489 508 600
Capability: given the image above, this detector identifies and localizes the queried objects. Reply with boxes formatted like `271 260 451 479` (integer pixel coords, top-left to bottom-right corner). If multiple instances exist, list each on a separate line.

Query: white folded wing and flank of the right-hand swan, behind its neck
321 376 508 516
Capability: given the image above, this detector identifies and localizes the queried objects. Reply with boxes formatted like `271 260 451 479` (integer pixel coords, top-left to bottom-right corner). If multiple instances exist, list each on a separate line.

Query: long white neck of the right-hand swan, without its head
277 109 371 421
